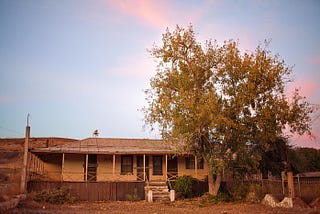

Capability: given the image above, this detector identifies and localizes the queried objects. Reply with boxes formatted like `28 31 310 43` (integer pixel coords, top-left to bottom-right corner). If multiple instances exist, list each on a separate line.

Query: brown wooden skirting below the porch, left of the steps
28 181 145 201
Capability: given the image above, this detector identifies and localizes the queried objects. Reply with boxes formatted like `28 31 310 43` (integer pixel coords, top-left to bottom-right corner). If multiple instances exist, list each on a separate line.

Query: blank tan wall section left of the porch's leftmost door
62 154 85 181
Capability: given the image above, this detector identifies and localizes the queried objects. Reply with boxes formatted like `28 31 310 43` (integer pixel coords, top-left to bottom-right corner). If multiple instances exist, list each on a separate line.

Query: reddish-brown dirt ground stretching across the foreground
6 199 320 214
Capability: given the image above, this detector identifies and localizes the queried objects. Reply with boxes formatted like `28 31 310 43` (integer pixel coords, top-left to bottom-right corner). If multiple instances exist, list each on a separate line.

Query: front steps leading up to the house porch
144 181 170 201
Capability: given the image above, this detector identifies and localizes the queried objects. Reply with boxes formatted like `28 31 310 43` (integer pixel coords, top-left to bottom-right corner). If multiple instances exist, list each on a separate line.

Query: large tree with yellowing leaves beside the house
144 25 313 195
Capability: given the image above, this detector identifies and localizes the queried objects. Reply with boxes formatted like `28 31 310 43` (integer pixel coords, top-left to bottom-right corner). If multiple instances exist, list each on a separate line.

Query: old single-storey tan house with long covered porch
28 138 208 200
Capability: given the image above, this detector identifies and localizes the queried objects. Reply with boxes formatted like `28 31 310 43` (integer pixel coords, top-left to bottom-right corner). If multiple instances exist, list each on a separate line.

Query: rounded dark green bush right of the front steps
174 175 196 198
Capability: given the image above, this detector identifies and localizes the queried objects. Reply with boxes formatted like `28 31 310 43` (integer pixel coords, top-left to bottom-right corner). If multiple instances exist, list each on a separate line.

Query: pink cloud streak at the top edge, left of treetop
105 0 170 28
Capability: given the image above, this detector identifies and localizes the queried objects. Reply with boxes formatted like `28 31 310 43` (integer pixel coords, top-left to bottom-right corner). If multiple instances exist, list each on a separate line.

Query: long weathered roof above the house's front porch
30 138 177 154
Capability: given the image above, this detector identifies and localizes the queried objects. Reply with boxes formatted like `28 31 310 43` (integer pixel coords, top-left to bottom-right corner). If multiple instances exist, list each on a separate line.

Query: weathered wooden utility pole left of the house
20 114 30 194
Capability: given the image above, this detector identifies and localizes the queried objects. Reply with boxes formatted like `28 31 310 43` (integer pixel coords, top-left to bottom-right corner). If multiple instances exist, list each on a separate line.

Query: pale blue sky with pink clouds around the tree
0 0 320 148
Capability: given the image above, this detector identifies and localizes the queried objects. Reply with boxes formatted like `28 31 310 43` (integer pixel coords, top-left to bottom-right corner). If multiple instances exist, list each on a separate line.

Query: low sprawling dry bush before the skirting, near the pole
34 189 76 204
